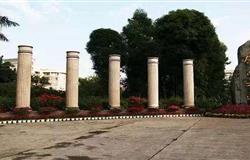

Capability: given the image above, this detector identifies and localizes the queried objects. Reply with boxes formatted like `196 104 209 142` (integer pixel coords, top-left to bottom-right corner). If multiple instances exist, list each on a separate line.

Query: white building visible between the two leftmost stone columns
34 69 66 91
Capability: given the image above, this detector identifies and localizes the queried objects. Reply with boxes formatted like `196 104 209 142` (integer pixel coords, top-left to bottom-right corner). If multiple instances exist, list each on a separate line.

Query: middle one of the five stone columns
109 54 120 108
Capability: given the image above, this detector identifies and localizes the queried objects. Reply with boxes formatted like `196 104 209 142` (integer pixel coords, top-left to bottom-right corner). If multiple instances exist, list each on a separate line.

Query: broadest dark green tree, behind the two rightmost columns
155 9 228 97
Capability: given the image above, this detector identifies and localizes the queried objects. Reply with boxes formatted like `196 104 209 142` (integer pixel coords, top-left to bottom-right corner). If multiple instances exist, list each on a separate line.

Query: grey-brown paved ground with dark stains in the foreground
0 117 250 160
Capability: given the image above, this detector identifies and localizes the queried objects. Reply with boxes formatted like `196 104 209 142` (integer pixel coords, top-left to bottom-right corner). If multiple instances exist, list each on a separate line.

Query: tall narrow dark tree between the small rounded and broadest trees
122 9 157 96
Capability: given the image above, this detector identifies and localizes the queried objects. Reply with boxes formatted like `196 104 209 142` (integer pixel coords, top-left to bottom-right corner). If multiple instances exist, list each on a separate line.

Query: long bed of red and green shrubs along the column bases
0 94 204 120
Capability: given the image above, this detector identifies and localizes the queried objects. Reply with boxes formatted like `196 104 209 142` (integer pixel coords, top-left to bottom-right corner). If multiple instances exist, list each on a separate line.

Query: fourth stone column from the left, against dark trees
148 57 159 108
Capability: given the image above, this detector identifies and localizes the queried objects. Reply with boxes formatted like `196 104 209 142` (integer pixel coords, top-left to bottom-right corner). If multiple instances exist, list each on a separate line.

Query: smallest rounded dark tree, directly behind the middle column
87 28 126 95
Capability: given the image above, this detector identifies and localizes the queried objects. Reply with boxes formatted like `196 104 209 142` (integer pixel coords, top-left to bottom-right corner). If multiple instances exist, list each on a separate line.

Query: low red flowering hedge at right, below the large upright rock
215 104 250 114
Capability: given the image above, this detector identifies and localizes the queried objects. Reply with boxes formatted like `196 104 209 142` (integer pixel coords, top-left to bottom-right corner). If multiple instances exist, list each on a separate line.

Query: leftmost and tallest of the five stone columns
15 45 33 111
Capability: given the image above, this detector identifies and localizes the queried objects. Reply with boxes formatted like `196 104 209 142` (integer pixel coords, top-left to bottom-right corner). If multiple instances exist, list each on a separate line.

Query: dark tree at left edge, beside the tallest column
0 56 16 83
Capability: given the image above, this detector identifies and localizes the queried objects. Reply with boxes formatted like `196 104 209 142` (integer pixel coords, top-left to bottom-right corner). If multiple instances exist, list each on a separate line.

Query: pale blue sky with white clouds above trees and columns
0 0 250 77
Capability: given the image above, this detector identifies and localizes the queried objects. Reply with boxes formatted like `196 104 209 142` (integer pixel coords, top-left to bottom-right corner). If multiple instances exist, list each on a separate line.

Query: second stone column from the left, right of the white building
66 51 80 110
